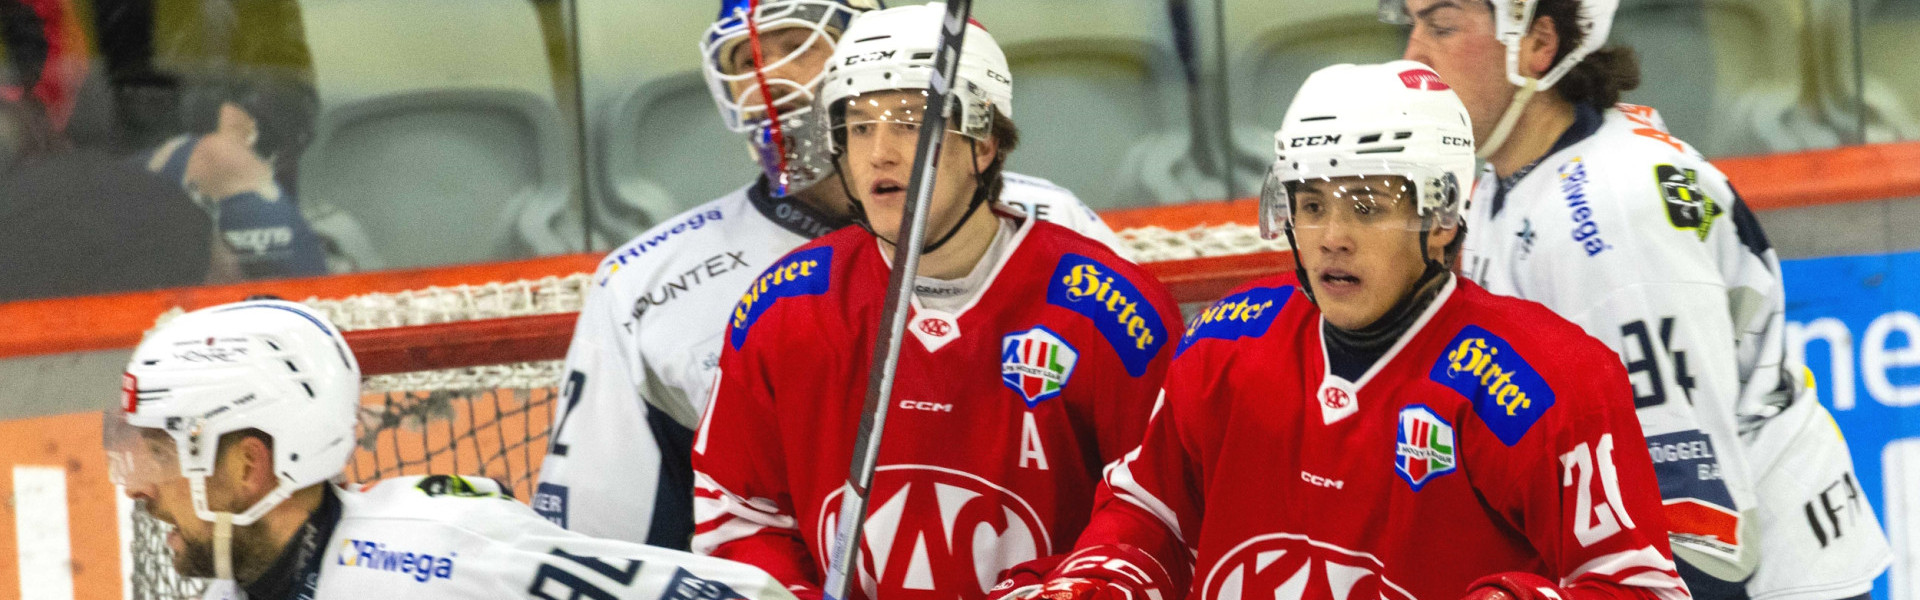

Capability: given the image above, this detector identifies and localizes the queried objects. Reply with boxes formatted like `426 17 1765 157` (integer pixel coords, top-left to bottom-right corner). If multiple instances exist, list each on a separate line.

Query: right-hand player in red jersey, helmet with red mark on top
1000 62 1688 600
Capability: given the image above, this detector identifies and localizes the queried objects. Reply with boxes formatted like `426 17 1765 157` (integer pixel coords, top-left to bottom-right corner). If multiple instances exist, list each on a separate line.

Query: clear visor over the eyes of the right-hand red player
1260 169 1427 238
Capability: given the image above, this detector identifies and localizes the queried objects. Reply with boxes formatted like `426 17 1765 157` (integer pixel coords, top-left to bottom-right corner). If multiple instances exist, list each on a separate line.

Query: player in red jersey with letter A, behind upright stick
693 4 1181 600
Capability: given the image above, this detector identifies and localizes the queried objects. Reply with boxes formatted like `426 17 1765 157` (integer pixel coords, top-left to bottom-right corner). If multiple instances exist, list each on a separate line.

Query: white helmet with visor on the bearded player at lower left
106 300 359 525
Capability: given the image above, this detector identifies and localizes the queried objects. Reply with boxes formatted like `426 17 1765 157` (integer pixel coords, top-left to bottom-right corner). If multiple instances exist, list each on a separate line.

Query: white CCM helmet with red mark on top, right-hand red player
1260 60 1475 240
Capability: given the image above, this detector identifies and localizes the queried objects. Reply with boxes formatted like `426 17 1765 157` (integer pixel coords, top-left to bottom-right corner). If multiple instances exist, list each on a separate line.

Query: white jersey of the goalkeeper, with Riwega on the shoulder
534 173 1121 550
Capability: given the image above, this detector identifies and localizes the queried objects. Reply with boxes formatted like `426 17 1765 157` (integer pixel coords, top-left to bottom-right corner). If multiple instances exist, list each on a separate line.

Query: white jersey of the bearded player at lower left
215 475 793 600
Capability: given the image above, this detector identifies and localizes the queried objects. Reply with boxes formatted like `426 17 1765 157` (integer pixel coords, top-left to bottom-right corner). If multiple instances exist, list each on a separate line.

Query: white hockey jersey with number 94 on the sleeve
1461 104 1887 600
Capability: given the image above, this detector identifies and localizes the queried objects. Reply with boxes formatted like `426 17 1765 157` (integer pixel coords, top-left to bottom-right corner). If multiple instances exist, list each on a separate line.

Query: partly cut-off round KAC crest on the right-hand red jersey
1196 533 1413 600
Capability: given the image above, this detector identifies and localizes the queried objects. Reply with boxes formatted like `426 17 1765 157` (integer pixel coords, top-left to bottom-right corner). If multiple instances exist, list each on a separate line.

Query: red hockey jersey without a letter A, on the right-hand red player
1069 275 1686 600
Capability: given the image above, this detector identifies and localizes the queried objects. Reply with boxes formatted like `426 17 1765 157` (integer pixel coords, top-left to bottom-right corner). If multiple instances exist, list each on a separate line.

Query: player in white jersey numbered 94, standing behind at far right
1380 0 1889 600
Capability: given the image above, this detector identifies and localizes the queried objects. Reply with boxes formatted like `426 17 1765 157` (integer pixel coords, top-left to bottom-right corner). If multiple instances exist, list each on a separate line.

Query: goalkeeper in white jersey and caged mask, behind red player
534 0 1119 548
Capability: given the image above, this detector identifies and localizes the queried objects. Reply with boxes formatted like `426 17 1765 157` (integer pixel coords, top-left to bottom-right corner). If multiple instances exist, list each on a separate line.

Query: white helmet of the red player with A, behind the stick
820 2 1014 154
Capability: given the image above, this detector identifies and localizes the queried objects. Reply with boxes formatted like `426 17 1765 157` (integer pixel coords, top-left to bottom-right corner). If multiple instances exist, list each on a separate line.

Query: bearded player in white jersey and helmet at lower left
104 300 793 600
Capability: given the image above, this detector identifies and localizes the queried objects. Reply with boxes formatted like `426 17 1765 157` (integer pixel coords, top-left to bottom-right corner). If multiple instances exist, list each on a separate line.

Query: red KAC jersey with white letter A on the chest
693 219 1181 600
